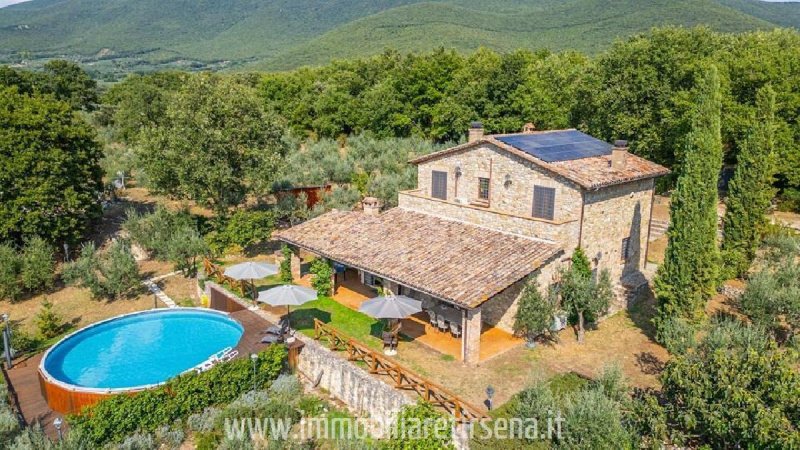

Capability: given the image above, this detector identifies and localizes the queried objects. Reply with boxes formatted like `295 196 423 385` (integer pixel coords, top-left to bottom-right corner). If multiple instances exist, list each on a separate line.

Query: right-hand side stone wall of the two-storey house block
581 179 654 286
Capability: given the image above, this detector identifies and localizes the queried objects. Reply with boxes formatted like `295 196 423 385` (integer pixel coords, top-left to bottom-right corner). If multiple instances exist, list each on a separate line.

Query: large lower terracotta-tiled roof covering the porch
274 208 560 307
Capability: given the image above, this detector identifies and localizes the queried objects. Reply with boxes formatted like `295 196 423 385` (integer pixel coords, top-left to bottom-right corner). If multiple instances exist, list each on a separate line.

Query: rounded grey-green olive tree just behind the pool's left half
63 240 141 300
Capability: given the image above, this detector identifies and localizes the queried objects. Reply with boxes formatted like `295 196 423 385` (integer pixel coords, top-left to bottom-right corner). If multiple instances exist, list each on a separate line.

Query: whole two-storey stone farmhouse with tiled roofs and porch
275 122 669 364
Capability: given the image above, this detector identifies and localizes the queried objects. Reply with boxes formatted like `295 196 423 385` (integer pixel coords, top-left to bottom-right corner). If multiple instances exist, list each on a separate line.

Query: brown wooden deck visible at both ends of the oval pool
3 310 272 439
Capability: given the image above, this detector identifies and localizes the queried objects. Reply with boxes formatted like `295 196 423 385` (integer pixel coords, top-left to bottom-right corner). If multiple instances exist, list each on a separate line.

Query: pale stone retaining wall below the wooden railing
297 337 414 437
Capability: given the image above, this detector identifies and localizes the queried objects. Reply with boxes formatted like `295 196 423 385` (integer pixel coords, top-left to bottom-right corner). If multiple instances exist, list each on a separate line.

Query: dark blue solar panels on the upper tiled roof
495 130 612 162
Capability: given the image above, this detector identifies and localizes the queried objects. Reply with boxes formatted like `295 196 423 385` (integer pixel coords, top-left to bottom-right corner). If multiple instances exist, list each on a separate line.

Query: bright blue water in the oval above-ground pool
43 309 244 389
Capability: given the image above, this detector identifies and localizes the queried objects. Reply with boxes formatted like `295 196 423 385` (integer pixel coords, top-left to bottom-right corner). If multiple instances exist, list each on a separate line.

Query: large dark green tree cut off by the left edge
0 88 102 248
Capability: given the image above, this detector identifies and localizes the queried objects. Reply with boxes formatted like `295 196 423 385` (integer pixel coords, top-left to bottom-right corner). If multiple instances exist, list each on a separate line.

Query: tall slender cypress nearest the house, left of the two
655 66 722 325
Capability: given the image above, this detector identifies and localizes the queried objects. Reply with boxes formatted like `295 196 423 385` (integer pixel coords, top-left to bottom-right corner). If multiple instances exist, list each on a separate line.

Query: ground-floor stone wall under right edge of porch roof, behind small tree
481 253 569 333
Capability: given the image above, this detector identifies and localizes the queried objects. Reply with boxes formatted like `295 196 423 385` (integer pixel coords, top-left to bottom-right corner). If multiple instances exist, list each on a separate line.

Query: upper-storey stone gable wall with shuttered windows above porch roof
400 144 582 241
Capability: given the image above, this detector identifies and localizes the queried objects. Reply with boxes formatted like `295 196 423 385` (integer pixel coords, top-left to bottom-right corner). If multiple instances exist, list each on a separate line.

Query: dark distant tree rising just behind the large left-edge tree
44 59 98 111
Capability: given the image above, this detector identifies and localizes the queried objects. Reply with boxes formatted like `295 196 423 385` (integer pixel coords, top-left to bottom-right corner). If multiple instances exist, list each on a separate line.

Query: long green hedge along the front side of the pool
69 346 286 446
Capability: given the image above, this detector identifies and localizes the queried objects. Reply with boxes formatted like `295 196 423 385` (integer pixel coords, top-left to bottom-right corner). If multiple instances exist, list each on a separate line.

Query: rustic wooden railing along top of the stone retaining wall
314 319 486 422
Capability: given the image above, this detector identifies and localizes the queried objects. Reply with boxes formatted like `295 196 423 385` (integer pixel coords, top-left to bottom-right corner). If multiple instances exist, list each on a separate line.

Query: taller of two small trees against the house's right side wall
557 248 614 342
